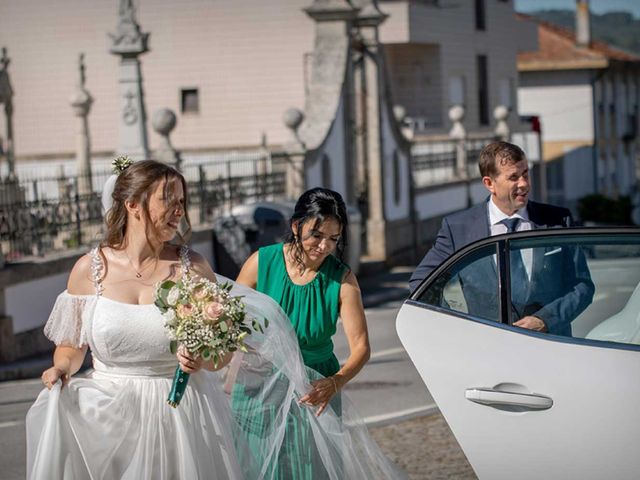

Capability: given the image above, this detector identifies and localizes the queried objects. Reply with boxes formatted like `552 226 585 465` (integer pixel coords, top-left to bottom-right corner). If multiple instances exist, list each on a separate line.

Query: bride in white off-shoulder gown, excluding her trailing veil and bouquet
27 161 250 479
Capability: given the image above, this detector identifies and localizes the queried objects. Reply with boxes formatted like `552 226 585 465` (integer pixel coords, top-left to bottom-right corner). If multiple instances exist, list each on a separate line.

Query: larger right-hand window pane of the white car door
510 234 640 345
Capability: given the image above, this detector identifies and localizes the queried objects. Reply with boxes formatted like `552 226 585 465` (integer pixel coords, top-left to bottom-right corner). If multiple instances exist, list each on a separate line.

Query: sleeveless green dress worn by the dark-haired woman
232 243 349 480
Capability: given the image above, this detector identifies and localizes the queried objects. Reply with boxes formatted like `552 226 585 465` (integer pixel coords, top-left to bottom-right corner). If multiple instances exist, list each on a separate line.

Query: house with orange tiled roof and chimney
517 7 640 206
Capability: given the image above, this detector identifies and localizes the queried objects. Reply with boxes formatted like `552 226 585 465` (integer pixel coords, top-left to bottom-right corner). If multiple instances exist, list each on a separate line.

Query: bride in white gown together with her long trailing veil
26 160 405 480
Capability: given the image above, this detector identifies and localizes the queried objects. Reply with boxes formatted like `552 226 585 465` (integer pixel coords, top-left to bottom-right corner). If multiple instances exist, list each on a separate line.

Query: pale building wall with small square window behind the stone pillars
0 0 314 156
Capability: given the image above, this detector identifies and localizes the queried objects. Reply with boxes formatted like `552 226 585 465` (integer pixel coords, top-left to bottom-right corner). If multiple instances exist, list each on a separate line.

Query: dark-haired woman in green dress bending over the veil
233 188 370 479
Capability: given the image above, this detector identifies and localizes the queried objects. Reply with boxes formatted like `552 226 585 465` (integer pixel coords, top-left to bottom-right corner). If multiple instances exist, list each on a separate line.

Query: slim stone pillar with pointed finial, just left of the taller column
70 53 93 195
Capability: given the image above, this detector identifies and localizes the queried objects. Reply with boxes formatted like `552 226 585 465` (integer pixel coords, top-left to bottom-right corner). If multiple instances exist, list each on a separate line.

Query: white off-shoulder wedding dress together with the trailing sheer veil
26 248 406 480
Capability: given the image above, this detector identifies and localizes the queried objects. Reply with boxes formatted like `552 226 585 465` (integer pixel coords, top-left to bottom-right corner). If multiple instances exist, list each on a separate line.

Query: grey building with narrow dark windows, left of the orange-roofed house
379 0 519 135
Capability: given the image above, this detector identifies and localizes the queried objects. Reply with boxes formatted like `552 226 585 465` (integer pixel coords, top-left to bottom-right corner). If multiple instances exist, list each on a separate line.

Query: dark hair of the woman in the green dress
285 187 349 269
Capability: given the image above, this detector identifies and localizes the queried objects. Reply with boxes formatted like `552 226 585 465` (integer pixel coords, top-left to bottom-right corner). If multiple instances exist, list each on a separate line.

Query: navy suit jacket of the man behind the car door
409 201 595 336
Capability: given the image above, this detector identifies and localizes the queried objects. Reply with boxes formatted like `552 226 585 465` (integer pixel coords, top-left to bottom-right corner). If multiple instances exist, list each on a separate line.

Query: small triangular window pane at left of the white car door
418 244 500 322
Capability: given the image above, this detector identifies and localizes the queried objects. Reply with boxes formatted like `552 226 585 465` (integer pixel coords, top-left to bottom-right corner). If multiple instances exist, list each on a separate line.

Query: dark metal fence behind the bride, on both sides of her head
0 152 286 262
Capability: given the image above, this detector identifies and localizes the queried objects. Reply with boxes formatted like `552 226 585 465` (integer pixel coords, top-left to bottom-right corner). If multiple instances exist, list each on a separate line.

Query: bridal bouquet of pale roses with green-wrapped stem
154 275 268 408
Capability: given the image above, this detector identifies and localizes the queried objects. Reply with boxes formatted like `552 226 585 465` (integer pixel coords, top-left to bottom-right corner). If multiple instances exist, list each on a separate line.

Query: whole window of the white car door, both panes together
418 232 640 345
